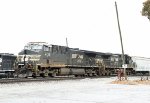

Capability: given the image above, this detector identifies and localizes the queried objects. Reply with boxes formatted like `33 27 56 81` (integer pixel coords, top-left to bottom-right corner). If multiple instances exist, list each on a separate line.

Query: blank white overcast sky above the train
0 0 150 57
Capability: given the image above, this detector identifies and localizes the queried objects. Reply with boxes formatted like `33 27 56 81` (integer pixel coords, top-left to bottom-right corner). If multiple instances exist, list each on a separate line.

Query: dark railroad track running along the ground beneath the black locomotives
0 76 115 84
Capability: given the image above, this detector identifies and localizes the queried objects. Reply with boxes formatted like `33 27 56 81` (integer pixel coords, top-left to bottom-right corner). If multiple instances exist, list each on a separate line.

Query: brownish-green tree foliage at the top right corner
142 0 150 20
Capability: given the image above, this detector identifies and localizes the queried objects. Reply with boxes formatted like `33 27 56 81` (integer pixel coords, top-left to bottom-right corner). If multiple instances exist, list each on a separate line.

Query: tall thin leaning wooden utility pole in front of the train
115 1 127 79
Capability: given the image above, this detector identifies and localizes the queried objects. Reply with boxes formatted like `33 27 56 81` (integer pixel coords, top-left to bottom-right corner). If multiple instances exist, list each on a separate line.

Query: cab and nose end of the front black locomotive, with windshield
17 42 50 77
